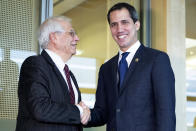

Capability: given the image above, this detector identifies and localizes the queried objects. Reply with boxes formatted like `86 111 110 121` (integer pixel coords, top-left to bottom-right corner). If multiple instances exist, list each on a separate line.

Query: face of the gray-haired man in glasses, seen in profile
56 22 79 56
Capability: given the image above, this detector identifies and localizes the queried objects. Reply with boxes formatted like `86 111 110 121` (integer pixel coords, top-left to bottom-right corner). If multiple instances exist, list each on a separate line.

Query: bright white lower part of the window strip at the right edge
186 38 196 127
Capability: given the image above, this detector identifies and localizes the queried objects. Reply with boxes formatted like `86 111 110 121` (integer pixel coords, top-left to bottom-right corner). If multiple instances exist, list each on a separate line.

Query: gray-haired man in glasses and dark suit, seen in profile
16 16 89 131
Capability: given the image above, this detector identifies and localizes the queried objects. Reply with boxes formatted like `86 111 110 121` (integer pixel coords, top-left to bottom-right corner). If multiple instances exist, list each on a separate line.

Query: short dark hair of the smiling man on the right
107 3 138 24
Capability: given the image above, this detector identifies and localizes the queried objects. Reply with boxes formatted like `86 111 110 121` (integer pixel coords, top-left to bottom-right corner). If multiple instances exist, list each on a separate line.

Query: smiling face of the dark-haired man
110 8 140 51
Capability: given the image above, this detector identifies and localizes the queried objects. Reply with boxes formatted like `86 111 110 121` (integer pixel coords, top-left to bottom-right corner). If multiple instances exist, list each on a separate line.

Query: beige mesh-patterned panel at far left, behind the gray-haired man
0 0 40 131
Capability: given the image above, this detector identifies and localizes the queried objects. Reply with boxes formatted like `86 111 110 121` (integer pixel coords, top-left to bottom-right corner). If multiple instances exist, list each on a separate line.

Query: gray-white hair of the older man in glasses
38 16 71 49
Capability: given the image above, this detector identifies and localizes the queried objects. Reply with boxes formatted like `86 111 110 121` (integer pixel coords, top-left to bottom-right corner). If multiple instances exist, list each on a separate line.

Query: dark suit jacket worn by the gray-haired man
16 50 82 131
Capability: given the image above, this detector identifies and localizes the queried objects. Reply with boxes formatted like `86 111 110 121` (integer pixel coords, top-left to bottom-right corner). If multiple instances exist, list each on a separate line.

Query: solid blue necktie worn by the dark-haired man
118 52 129 87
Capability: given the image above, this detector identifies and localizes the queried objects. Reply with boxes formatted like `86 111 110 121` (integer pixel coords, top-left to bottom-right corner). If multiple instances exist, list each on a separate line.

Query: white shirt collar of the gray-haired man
45 49 66 70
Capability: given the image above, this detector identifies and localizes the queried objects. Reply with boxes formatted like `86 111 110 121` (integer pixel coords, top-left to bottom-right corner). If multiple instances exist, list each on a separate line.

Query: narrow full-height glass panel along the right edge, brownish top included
185 0 196 131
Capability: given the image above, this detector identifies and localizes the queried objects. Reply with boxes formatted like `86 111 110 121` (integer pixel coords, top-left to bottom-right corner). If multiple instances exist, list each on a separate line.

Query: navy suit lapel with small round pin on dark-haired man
120 44 145 93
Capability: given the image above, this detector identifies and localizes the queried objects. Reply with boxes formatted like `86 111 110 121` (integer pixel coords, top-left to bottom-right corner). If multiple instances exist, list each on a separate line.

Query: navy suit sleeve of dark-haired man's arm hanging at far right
152 53 176 131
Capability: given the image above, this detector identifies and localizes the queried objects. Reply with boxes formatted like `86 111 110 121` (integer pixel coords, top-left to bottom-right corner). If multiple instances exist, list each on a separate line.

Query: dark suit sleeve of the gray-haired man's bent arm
19 57 80 124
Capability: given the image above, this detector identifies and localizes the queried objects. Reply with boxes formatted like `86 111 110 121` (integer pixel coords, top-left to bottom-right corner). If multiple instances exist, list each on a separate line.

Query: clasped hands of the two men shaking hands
79 101 91 125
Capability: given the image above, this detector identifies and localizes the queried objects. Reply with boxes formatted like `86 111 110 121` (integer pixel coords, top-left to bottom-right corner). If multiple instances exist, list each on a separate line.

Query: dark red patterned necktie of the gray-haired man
64 64 75 104
